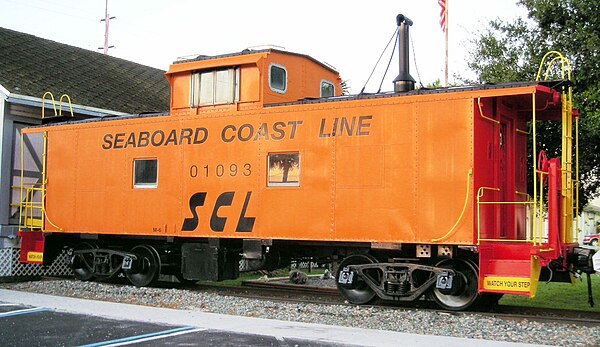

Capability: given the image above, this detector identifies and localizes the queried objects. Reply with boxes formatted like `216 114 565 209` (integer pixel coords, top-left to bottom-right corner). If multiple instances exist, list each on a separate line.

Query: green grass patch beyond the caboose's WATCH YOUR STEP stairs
500 275 600 313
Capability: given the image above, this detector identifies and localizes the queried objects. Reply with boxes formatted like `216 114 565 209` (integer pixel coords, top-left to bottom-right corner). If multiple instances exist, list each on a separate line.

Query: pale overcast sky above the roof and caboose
0 0 525 93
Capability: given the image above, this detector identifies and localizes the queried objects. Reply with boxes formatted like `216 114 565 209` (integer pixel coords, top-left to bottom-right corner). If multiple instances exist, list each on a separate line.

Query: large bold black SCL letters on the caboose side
181 192 256 232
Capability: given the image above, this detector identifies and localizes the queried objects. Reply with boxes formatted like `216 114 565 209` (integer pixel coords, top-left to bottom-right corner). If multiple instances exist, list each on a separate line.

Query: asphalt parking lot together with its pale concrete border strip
0 289 548 347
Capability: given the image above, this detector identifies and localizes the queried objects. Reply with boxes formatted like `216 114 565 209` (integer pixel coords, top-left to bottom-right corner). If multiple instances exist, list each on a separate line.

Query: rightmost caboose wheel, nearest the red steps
430 259 479 311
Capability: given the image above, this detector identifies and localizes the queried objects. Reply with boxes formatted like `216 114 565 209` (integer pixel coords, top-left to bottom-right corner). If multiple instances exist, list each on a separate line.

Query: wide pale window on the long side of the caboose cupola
190 68 239 107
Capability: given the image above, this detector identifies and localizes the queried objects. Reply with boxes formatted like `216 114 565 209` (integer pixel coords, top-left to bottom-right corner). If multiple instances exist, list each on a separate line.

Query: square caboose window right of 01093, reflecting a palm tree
267 152 300 187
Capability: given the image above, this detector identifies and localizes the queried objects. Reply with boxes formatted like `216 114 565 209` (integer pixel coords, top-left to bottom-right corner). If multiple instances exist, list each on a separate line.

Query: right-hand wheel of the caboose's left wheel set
124 245 161 287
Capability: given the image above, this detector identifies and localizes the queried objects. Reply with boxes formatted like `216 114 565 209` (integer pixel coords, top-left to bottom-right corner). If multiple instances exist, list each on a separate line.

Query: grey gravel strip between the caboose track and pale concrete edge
3 280 600 346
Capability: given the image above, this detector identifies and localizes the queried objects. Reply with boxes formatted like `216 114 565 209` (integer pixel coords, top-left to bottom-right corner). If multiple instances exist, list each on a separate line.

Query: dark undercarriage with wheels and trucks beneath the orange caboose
44 234 510 310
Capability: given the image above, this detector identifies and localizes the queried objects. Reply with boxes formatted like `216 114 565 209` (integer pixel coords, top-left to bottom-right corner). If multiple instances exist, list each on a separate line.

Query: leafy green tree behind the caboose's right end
469 0 600 206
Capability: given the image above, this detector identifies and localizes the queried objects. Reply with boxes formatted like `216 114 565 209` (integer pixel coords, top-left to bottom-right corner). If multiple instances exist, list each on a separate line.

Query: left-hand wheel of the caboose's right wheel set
335 254 379 305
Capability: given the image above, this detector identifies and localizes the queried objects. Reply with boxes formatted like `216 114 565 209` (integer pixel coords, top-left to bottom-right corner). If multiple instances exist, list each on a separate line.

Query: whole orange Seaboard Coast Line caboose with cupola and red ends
16 16 592 309
